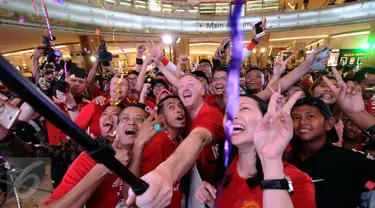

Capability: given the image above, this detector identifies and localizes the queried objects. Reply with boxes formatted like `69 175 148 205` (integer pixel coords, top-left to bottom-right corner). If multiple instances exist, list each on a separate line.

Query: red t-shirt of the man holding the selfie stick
187 103 224 186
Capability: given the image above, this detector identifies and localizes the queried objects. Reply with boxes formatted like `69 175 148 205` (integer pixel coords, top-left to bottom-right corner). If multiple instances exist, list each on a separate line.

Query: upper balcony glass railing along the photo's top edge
96 0 365 16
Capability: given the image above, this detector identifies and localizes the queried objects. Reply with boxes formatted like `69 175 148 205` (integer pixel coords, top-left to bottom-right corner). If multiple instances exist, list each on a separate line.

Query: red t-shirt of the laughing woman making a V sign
217 155 316 208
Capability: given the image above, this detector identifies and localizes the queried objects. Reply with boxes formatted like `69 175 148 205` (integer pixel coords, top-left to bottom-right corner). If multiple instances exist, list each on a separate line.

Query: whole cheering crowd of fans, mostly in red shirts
0 18 375 208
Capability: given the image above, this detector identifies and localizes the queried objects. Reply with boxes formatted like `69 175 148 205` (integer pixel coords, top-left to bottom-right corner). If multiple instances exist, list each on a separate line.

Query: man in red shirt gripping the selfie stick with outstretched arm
127 75 224 207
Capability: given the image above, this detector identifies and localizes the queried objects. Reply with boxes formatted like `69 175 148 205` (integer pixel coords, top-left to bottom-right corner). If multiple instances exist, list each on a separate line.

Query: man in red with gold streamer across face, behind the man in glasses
75 74 129 136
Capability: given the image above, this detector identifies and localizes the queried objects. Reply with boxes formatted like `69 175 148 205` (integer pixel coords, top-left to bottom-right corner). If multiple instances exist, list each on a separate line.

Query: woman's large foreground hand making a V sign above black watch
254 92 302 163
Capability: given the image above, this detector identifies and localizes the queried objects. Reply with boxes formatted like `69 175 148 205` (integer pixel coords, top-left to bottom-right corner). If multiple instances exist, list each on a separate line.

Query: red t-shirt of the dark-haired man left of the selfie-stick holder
141 131 182 208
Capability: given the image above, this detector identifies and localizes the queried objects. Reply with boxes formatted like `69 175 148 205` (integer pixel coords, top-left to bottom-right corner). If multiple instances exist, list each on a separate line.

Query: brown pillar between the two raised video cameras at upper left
79 35 103 73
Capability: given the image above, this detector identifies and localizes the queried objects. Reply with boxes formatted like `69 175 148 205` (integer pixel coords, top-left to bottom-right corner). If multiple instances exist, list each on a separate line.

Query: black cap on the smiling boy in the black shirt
292 97 339 143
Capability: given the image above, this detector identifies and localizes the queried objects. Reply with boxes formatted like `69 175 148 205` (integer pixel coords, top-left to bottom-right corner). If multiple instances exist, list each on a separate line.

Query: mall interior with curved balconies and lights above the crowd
0 0 375 76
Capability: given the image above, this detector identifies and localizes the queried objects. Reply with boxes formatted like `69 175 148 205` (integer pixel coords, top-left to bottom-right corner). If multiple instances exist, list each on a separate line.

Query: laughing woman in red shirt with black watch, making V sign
196 93 316 208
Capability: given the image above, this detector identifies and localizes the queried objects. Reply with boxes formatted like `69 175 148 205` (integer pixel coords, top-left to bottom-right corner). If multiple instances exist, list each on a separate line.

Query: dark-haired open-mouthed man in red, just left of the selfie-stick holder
123 95 186 208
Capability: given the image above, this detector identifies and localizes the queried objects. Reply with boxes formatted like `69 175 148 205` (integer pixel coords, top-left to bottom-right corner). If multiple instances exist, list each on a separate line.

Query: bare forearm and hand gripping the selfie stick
126 127 213 208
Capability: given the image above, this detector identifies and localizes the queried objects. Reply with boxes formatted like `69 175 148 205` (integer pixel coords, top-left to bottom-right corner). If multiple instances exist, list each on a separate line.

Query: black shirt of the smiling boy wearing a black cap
293 142 375 208
